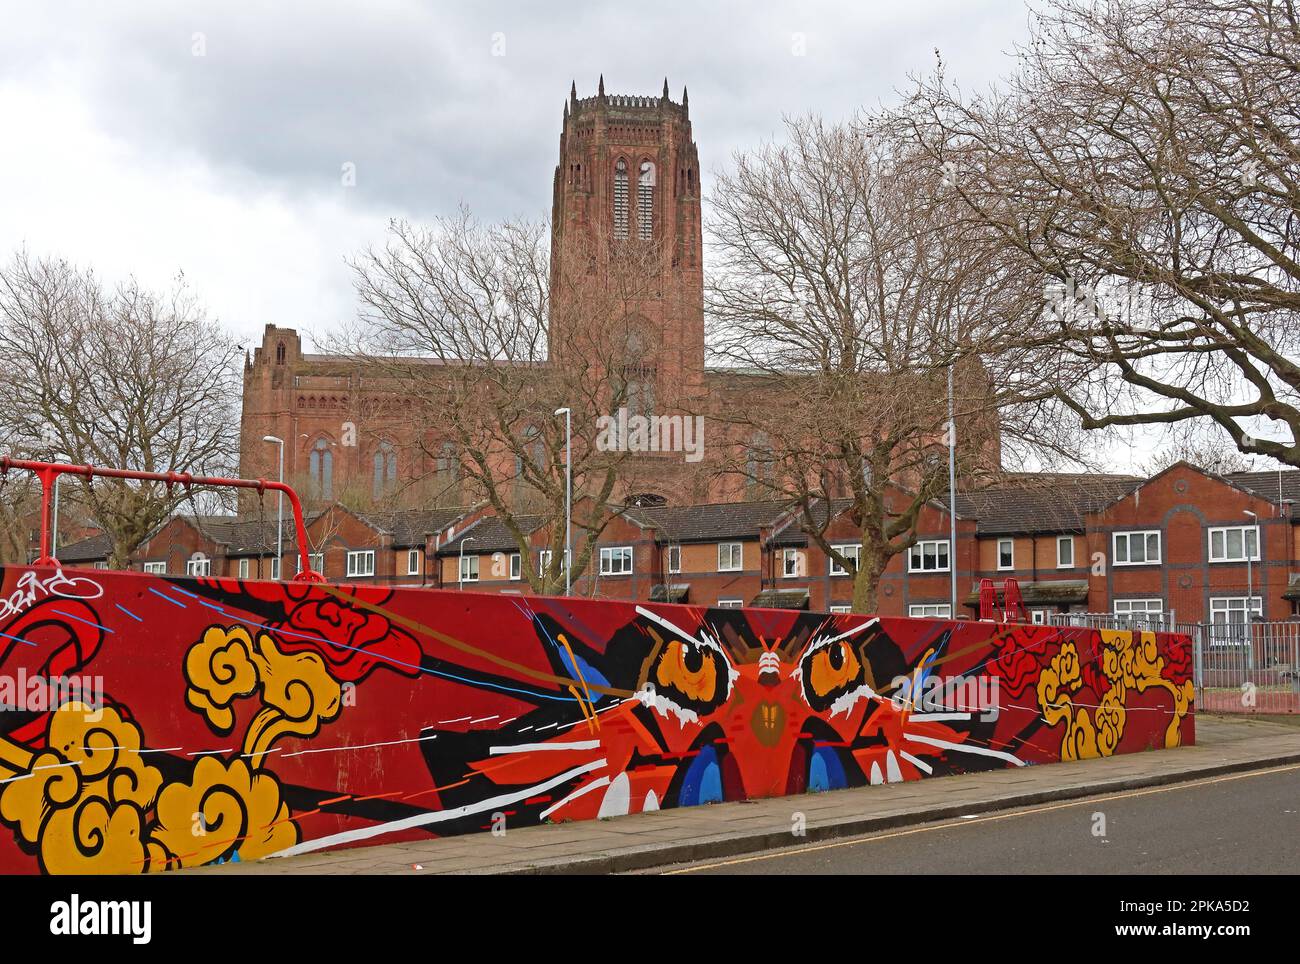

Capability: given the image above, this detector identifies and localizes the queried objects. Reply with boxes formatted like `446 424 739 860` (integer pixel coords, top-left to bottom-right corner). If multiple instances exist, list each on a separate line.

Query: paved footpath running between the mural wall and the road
190 716 1300 874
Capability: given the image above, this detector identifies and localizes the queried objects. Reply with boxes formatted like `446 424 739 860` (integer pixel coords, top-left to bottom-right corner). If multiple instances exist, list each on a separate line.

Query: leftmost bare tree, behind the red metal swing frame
0 252 239 568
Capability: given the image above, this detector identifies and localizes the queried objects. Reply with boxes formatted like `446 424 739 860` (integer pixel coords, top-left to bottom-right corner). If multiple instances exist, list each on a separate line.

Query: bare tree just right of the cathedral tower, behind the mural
707 117 1066 612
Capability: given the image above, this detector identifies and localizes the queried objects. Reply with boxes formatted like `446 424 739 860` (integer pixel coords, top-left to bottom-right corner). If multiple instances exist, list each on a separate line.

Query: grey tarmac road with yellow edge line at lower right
660 765 1300 876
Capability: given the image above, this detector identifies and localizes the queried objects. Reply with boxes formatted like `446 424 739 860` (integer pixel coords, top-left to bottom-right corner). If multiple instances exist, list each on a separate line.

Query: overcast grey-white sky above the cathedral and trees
0 0 1027 355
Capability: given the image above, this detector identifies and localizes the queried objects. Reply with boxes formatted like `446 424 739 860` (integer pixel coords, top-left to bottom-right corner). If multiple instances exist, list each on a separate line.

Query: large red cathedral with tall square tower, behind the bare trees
241 77 744 504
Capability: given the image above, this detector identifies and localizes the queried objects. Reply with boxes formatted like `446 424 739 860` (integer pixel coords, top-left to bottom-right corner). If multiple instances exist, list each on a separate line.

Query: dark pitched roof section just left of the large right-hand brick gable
957 473 1144 535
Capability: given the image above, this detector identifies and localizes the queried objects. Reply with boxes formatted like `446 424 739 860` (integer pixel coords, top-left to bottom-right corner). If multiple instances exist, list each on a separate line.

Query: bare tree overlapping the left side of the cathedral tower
347 210 662 592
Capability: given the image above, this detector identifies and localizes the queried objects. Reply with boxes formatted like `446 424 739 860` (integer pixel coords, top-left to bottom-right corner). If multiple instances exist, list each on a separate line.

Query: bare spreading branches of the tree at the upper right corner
911 0 1300 465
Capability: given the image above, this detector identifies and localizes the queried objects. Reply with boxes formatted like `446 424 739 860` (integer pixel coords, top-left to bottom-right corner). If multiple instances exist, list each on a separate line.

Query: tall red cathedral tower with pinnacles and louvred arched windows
550 75 705 402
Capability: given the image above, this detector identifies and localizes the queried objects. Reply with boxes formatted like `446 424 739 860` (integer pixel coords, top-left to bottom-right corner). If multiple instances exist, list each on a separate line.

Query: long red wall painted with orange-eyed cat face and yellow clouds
0 568 1193 873
